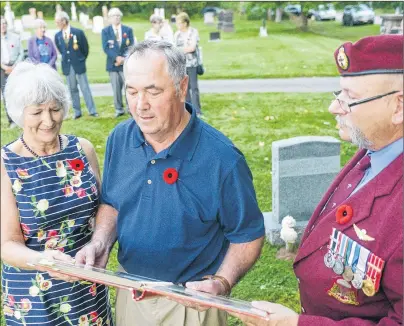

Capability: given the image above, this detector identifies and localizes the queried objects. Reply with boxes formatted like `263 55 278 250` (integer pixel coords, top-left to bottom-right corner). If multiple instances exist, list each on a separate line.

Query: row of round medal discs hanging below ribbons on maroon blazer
324 249 375 296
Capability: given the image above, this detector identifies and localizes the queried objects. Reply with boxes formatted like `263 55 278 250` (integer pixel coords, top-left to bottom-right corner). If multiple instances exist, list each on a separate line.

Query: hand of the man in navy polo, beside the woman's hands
75 241 109 268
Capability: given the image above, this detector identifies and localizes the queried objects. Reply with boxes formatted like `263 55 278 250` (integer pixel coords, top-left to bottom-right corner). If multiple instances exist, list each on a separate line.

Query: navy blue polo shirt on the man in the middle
102 105 265 282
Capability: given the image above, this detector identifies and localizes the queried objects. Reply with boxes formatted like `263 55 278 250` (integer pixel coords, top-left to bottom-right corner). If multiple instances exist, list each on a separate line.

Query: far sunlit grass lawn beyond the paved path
33 15 380 83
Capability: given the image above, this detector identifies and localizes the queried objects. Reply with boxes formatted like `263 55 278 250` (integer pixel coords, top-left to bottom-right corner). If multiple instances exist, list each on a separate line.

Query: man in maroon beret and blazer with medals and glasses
230 35 404 326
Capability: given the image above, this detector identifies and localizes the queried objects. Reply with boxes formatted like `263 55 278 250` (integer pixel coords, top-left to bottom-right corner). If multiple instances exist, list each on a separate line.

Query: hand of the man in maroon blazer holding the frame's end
230 301 299 326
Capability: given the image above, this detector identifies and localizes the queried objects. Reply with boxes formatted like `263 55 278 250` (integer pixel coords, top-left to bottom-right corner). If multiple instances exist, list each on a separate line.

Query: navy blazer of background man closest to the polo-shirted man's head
102 25 135 71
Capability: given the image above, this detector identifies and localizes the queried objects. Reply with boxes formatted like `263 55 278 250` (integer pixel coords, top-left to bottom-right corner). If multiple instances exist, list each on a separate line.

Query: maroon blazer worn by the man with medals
294 150 403 326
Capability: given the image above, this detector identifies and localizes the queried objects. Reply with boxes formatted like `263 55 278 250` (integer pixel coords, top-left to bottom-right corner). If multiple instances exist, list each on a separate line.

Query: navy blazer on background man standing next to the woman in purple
55 26 88 76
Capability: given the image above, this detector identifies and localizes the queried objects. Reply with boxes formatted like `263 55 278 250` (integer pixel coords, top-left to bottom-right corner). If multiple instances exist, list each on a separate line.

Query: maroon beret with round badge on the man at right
334 35 404 76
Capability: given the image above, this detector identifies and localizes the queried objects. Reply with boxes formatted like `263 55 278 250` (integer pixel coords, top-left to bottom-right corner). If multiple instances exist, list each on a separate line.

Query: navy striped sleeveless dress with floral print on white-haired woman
1 135 113 326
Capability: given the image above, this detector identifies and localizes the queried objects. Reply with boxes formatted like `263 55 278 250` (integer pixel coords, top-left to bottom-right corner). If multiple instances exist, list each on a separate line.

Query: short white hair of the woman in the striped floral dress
4 61 70 127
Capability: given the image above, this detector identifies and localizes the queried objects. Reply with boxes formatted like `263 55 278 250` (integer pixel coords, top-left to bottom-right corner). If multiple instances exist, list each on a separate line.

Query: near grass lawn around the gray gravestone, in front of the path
1 93 355 326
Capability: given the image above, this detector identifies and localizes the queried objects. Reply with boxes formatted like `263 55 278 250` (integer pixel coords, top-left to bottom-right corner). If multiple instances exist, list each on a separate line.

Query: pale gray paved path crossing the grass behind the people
85 77 339 96
